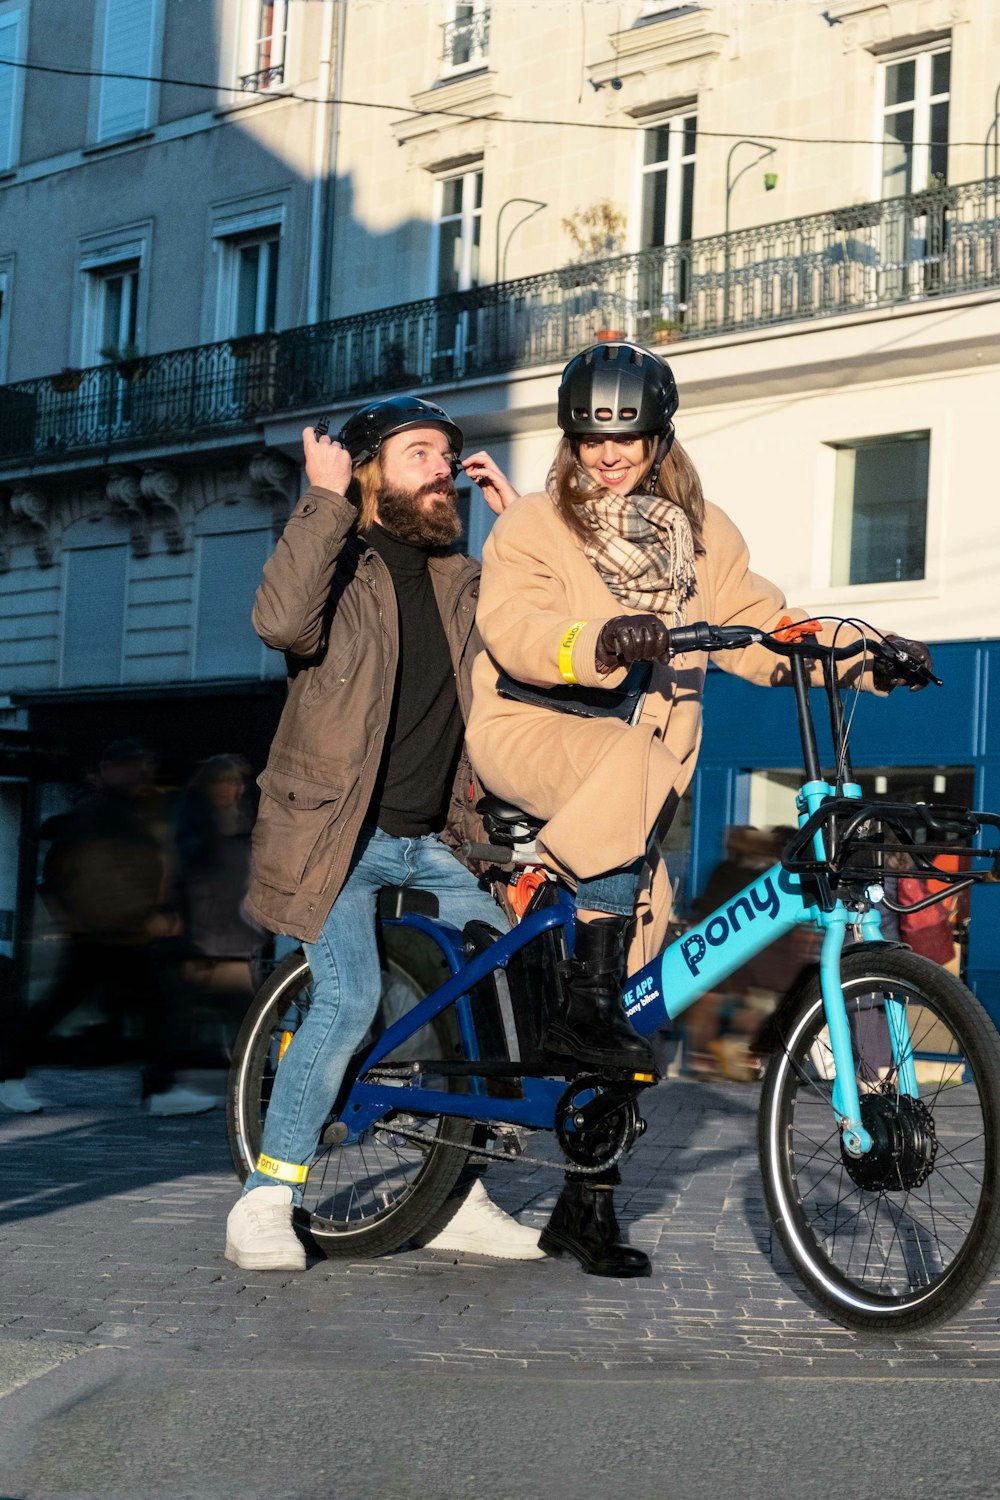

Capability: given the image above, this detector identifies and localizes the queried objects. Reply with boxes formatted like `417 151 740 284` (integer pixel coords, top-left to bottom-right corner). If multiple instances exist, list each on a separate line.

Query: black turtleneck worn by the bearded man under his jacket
367 525 463 839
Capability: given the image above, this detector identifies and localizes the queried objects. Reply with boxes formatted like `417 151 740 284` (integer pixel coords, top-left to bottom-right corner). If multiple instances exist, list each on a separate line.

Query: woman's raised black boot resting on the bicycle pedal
544 917 654 1073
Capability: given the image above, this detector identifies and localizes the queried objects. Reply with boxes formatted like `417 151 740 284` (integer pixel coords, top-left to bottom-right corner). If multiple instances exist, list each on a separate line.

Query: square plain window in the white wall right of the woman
831 432 931 585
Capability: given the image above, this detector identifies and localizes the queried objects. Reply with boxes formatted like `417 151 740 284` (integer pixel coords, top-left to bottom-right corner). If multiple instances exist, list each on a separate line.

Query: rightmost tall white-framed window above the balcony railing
882 44 952 198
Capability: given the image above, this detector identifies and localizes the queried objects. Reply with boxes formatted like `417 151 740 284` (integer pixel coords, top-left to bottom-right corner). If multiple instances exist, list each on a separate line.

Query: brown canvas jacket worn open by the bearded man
246 486 481 942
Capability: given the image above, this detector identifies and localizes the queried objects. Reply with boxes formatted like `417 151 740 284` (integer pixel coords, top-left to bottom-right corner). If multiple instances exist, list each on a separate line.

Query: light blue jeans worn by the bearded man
243 828 507 1203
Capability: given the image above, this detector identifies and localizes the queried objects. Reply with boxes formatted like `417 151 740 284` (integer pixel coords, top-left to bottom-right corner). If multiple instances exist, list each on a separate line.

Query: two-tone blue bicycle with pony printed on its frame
228 623 1000 1331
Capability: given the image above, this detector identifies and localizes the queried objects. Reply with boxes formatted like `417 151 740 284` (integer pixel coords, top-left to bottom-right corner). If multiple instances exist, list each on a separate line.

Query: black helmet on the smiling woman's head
558 344 679 438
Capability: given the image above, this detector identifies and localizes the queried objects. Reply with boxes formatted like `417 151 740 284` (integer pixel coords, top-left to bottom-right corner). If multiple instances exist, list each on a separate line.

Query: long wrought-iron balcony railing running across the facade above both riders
0 177 1000 467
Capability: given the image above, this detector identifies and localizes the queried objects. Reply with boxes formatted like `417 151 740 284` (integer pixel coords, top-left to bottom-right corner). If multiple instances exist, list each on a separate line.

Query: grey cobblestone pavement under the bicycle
0 1070 1000 1394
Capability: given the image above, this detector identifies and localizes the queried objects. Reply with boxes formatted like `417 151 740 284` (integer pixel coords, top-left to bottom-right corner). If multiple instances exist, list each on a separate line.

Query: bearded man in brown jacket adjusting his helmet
226 396 543 1271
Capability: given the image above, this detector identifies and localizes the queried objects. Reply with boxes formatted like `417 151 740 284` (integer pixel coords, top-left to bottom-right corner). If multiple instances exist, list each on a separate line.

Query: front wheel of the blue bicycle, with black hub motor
759 948 1000 1329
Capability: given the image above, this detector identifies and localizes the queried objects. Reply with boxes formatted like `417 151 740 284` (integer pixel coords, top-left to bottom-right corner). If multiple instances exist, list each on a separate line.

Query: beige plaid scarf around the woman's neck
547 464 697 629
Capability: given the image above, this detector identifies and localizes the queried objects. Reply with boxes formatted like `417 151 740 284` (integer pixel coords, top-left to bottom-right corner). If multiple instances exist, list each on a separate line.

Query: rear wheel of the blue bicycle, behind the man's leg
226 953 475 1259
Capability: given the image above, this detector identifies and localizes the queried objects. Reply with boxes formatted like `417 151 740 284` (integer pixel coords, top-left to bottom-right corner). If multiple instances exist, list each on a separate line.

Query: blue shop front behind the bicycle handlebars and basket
684 641 1000 1025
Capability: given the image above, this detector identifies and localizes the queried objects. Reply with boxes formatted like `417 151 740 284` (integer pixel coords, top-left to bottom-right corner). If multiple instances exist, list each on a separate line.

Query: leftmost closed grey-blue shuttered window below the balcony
61 546 129 687
